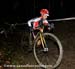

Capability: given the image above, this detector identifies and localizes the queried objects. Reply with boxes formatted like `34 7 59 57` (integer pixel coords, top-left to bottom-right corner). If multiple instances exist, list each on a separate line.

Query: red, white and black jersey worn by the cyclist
28 17 48 29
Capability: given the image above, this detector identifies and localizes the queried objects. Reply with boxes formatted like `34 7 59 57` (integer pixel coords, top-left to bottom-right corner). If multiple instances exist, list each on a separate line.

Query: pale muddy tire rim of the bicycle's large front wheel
33 33 63 69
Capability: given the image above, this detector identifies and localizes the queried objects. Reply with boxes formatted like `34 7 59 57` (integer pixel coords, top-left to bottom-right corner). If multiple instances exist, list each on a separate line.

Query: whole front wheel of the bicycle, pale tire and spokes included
33 33 63 69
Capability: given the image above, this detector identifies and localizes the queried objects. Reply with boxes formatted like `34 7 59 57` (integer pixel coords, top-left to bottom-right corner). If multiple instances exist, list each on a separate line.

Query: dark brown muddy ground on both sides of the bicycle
0 21 75 69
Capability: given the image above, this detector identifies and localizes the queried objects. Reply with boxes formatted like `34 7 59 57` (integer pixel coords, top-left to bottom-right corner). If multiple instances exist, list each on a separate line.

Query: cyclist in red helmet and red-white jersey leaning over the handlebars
28 9 54 51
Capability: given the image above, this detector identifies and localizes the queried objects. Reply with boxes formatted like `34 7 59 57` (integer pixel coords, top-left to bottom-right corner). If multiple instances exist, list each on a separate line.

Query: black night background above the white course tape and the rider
0 0 75 23
